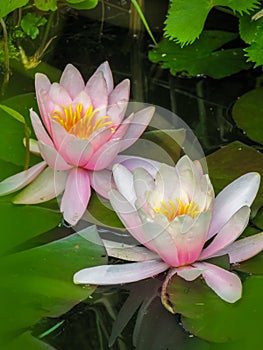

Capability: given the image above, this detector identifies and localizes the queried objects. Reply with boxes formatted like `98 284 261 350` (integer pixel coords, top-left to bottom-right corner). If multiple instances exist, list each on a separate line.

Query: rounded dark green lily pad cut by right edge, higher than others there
232 88 263 144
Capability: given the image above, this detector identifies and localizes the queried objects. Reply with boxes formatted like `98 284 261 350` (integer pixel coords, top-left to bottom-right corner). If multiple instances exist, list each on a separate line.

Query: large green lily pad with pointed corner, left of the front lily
0 226 106 344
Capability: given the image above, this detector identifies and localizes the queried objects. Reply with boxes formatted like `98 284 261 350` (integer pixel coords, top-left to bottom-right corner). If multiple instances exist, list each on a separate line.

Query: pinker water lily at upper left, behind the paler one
0 62 154 225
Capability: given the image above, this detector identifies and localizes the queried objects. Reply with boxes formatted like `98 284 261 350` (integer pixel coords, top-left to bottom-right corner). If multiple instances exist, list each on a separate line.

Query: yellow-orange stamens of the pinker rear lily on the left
52 103 113 139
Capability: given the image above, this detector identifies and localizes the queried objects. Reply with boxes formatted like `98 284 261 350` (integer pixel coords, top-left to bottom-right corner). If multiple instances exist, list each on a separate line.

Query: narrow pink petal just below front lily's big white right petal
202 206 250 260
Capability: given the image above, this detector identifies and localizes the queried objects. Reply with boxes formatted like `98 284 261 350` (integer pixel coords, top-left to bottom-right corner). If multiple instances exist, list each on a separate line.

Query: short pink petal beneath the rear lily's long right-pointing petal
84 139 120 171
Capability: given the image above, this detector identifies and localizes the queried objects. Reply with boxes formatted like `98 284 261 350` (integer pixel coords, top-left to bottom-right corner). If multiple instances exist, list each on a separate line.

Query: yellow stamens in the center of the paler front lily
154 198 200 221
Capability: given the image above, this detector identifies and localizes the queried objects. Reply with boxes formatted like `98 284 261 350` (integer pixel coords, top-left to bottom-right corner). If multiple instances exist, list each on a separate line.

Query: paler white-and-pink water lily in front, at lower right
74 156 263 303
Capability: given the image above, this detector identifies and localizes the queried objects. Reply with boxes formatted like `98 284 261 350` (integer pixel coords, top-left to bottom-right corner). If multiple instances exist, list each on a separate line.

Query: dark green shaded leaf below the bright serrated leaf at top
149 30 250 79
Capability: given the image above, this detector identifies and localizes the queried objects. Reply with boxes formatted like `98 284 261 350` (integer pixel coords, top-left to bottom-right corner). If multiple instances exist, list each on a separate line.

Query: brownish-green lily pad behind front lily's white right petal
206 141 263 210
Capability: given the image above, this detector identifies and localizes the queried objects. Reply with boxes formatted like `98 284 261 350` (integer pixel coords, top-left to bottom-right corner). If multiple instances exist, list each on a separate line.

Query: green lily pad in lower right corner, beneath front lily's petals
167 276 263 344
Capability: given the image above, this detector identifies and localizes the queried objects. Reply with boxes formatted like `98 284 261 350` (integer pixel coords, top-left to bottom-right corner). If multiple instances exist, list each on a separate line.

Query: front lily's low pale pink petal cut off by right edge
210 232 263 264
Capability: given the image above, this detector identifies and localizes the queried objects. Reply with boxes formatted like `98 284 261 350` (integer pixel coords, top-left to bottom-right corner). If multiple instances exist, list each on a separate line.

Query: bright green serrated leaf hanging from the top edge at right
165 0 260 45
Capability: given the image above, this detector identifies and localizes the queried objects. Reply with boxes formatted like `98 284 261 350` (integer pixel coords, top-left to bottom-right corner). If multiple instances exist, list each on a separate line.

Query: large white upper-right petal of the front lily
207 173 260 239
